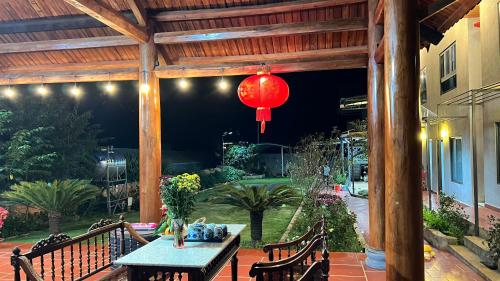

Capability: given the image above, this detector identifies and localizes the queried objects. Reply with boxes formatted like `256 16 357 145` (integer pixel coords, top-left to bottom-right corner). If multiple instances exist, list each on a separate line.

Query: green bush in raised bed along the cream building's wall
424 194 469 241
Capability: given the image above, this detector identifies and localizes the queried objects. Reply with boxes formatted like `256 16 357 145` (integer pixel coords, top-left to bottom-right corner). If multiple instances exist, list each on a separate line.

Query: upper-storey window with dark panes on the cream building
439 42 457 94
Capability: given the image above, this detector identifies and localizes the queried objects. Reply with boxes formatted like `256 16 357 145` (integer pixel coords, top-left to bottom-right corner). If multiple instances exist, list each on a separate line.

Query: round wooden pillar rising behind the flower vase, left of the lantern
139 36 161 222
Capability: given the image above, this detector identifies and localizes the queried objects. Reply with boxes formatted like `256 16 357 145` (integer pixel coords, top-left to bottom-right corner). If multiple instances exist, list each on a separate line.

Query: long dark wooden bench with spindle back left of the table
11 216 148 281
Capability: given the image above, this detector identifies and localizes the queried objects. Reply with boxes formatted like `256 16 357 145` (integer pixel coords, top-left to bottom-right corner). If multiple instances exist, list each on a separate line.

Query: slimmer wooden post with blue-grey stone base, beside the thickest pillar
366 0 385 269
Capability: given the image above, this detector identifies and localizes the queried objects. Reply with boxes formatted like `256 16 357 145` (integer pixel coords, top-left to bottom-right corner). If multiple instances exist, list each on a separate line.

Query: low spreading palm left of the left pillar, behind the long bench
2 180 99 234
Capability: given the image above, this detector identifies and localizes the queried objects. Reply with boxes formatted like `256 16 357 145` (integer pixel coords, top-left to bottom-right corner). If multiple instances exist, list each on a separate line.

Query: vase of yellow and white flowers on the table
160 173 200 248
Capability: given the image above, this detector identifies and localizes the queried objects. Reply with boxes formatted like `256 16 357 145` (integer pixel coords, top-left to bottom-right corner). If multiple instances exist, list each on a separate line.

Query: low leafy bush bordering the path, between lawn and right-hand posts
290 198 362 252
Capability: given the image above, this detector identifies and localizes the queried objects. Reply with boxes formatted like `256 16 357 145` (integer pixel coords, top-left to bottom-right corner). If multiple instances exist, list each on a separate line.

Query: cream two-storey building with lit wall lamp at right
420 0 500 210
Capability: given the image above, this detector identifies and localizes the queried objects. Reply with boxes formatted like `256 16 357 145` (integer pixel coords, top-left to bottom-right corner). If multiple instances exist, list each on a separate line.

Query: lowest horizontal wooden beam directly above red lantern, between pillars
155 58 367 78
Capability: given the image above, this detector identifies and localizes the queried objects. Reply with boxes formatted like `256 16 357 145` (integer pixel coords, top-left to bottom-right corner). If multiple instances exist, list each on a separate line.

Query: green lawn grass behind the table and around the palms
6 178 297 245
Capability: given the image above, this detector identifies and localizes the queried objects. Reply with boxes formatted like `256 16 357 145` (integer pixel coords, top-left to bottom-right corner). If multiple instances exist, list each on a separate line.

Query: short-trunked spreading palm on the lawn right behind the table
213 185 300 244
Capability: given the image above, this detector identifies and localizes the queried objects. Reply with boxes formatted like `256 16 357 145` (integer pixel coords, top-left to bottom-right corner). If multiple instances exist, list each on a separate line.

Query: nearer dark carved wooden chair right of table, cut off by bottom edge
250 222 330 281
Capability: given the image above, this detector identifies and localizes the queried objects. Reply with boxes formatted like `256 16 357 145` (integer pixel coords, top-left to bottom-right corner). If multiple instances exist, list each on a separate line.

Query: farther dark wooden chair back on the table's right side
262 219 324 261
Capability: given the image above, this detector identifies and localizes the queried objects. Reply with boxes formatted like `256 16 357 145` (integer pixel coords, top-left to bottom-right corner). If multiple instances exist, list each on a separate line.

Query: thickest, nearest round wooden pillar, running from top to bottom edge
384 0 424 281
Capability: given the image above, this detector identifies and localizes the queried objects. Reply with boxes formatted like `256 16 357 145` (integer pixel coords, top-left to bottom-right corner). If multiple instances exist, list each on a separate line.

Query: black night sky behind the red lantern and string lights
52 69 366 151
